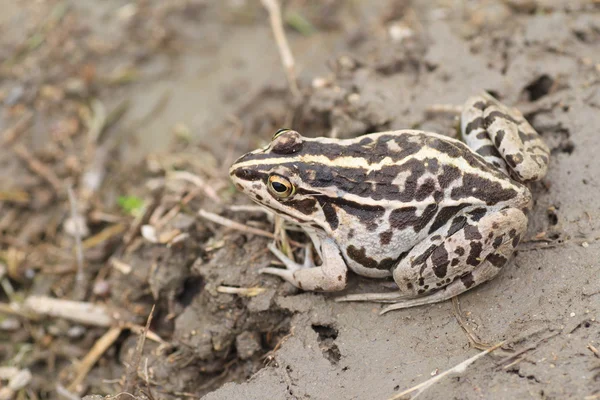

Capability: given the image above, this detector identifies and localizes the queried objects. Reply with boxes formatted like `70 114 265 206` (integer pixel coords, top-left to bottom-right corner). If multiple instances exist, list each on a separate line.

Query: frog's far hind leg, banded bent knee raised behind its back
461 93 550 182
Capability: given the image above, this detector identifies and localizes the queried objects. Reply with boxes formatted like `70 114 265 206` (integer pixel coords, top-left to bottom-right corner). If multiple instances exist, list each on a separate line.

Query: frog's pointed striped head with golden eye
229 129 327 228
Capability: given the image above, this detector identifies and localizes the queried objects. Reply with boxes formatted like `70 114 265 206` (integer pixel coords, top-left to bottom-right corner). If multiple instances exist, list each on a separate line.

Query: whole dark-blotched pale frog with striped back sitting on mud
229 92 550 313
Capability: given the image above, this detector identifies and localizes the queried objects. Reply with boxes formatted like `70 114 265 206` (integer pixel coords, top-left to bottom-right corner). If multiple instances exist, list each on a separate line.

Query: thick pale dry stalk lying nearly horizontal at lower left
23 296 114 326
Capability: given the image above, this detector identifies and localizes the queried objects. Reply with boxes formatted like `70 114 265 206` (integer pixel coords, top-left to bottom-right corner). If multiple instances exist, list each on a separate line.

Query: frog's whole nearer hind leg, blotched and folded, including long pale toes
337 208 527 313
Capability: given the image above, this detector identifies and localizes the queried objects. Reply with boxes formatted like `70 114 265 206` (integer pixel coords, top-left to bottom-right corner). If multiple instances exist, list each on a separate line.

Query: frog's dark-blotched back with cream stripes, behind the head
299 130 528 210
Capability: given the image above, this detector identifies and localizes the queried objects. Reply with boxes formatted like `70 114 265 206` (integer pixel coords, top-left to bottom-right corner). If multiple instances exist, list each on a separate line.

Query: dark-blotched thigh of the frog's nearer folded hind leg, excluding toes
384 208 527 312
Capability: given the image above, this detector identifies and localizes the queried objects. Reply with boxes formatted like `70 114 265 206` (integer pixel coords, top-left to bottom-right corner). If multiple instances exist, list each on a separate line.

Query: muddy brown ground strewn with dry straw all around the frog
0 0 600 400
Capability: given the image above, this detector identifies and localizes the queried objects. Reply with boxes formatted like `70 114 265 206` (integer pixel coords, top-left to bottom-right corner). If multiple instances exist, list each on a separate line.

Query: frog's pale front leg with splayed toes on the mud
259 239 348 292
